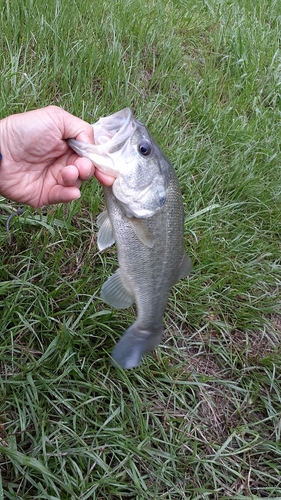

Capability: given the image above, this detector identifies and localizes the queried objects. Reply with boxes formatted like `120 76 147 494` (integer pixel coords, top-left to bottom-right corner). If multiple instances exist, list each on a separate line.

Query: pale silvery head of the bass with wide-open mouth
68 108 170 218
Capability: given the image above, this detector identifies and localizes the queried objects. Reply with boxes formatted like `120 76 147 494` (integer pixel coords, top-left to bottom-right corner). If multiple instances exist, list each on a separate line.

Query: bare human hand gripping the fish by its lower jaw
0 106 114 208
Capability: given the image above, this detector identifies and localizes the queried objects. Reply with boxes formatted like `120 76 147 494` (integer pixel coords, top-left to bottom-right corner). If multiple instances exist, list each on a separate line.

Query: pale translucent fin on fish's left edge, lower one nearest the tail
101 269 135 309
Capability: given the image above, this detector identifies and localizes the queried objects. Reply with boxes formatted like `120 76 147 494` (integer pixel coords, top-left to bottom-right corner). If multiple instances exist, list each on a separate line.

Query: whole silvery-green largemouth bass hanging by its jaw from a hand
68 108 192 369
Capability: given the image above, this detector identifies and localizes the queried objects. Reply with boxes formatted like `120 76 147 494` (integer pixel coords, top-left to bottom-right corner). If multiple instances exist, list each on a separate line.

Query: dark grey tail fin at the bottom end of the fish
109 321 164 369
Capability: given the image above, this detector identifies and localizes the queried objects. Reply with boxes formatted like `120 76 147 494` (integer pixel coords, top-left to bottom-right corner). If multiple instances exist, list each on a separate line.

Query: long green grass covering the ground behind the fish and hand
0 0 281 500
